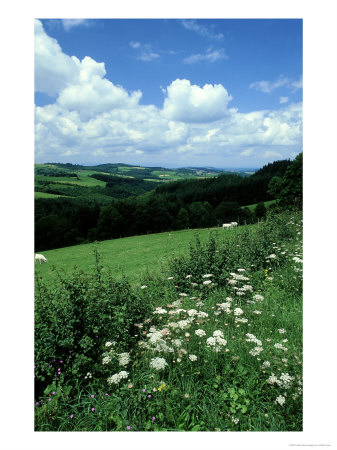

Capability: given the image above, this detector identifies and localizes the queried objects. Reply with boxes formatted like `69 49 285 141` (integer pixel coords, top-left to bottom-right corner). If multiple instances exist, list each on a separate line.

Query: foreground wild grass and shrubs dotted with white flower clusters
35 209 302 431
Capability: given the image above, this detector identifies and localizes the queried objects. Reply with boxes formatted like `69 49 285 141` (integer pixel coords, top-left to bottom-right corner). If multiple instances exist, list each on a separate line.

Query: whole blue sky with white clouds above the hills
35 19 302 167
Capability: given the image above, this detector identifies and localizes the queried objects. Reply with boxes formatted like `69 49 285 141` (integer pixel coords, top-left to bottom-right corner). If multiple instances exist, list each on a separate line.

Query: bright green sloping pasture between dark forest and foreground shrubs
35 226 245 282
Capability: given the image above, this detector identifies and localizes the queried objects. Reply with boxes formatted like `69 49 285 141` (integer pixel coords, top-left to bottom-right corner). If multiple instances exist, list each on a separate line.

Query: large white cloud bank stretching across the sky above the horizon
35 21 302 166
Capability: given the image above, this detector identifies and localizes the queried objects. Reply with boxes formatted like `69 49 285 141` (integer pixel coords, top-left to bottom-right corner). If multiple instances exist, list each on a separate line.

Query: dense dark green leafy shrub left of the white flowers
35 249 149 393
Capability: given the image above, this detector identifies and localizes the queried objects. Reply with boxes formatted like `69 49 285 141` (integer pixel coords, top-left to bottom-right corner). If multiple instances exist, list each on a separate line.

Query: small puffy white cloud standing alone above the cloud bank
163 79 232 123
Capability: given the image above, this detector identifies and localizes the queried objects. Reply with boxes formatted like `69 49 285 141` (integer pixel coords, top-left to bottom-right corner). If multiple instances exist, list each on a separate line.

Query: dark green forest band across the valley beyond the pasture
35 153 302 251
